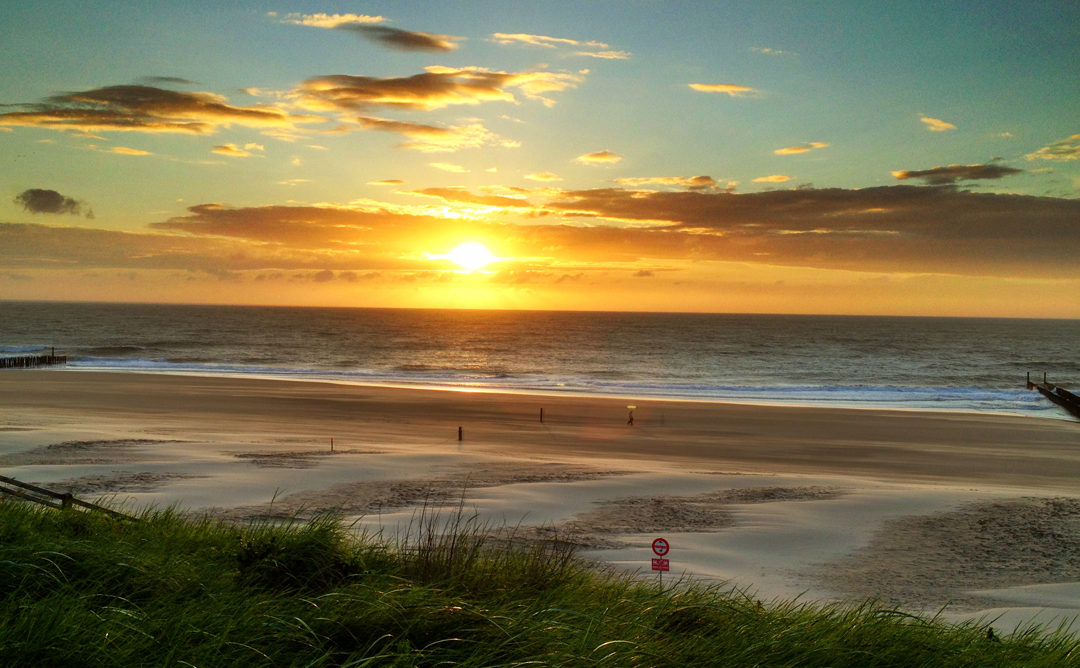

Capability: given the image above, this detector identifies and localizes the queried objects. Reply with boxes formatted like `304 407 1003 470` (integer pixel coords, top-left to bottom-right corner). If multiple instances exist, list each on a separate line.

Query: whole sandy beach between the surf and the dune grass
0 370 1080 632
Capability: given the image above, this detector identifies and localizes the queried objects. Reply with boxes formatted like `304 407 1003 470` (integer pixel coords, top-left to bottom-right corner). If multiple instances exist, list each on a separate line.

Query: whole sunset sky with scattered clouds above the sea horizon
0 0 1080 317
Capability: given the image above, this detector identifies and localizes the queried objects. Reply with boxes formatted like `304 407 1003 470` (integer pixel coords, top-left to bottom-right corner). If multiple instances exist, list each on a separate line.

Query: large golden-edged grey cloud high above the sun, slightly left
295 66 582 111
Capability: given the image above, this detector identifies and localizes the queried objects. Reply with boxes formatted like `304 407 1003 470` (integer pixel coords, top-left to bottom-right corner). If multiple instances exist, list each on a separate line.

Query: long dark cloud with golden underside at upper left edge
0 85 325 135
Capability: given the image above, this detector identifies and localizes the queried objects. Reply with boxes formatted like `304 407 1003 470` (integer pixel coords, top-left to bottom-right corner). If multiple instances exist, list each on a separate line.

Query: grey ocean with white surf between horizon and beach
0 301 1080 418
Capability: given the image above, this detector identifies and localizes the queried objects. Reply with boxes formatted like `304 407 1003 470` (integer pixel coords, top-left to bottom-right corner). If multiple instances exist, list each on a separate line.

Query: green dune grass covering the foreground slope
0 501 1080 668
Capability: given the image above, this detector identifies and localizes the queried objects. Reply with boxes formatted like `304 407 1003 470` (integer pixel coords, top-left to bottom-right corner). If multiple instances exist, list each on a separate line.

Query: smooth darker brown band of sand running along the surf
0 370 1080 494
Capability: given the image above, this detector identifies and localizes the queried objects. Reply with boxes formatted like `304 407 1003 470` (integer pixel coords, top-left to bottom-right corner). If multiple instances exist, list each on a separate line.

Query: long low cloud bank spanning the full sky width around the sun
8 185 1080 281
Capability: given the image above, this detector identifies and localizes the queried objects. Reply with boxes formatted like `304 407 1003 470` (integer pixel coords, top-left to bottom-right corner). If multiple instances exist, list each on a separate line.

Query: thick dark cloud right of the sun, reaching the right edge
537 185 1080 277
